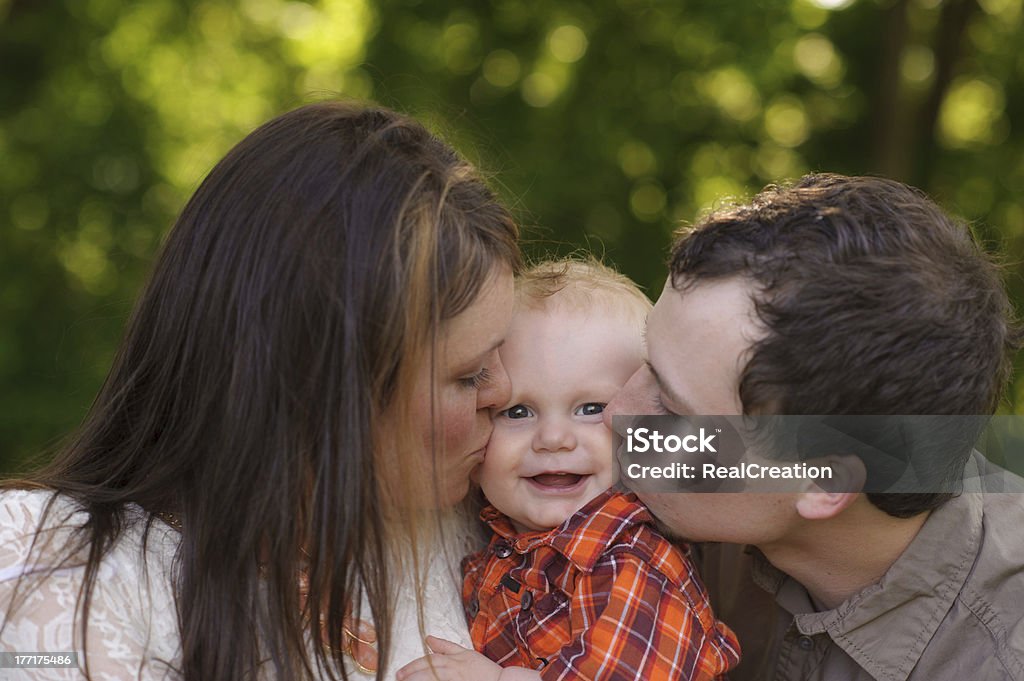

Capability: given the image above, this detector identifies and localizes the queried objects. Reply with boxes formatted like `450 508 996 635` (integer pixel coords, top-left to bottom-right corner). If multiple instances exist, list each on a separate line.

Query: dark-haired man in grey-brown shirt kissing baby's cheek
605 175 1024 681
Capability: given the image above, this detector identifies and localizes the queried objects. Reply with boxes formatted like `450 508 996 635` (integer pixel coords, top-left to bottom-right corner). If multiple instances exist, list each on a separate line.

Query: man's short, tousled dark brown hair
670 174 1019 517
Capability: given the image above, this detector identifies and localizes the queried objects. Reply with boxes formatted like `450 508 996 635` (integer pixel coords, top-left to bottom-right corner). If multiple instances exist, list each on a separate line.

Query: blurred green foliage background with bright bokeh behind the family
0 0 1024 471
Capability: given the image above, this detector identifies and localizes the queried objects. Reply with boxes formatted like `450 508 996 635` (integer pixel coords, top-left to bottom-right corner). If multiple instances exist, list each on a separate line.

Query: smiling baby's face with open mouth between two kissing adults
478 303 643 530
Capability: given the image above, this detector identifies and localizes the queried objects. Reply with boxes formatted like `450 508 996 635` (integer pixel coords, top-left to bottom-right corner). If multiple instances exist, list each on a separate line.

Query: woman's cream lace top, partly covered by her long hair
0 491 472 681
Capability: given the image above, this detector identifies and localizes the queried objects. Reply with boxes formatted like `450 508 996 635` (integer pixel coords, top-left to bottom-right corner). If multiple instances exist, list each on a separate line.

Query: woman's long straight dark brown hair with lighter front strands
3 103 519 681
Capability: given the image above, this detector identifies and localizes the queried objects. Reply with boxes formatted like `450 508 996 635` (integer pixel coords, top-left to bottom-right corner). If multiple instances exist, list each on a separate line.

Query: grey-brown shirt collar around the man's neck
753 493 982 681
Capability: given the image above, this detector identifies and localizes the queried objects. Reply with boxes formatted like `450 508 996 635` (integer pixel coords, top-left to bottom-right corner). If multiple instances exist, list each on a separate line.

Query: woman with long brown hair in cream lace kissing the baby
0 103 520 681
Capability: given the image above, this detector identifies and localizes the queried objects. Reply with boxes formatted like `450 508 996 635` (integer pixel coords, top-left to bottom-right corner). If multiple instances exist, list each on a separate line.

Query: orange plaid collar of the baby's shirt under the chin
480 490 651 570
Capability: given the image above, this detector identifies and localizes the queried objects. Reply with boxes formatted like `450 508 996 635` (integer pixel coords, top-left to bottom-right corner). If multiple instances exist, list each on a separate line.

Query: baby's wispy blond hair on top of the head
516 256 652 323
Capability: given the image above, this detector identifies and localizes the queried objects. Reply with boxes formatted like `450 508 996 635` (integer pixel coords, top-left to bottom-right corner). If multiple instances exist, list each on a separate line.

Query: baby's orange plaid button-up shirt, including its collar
462 490 739 681
